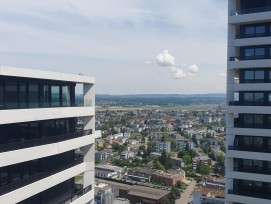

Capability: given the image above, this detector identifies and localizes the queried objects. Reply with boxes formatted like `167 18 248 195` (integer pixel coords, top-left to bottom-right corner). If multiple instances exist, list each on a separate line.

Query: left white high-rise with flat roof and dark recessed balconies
0 66 95 204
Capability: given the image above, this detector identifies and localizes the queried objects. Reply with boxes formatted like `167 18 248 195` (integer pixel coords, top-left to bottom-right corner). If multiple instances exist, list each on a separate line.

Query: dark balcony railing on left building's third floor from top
0 158 83 196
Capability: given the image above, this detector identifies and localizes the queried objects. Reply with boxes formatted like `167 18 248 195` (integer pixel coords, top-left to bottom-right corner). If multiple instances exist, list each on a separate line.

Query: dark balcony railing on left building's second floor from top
0 129 92 152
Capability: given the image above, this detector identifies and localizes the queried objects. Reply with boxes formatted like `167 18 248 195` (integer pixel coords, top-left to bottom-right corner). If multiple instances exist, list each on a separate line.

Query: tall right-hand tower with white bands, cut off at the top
226 0 271 204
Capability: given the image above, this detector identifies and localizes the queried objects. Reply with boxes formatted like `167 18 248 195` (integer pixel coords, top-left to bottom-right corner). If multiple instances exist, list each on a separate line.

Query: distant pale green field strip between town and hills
96 104 218 111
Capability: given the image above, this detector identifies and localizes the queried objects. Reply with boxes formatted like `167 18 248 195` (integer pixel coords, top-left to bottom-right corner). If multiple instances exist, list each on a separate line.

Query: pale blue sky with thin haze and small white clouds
0 0 227 94
